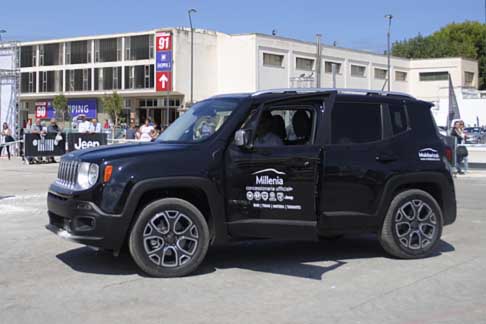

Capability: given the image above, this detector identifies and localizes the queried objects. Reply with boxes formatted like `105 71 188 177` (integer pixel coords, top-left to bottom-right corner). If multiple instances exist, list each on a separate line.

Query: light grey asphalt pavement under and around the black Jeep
0 159 486 324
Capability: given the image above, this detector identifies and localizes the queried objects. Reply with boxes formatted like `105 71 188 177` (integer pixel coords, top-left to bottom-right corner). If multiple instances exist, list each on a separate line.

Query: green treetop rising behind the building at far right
392 21 486 89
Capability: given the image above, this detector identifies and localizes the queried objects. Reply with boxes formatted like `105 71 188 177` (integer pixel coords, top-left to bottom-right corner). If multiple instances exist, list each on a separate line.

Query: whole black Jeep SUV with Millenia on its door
47 89 456 277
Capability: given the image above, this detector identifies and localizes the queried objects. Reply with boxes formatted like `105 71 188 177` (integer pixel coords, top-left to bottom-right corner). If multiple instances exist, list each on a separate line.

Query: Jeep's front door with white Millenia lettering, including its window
225 105 322 239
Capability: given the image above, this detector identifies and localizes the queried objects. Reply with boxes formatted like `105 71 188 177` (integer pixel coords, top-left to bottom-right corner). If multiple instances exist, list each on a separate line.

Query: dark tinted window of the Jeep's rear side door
331 102 382 144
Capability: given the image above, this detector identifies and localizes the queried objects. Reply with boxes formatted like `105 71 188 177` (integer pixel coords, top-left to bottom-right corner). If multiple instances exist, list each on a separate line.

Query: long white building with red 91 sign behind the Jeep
4 28 478 128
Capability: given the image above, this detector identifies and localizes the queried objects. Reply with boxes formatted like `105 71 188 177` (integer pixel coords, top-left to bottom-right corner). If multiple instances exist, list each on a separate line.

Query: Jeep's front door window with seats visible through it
255 106 314 146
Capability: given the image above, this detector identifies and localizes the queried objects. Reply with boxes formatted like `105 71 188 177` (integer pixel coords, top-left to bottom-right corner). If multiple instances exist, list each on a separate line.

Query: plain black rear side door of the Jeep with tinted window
319 96 399 230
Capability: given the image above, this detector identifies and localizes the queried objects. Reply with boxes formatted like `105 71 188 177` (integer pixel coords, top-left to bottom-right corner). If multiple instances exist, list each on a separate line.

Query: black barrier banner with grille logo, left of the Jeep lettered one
24 133 66 156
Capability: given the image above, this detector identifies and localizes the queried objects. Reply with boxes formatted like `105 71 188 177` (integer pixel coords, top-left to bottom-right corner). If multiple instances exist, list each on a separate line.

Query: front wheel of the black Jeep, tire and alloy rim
128 198 209 278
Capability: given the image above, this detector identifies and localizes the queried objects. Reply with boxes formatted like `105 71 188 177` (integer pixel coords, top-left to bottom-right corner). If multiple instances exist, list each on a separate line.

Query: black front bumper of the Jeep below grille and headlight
46 191 128 251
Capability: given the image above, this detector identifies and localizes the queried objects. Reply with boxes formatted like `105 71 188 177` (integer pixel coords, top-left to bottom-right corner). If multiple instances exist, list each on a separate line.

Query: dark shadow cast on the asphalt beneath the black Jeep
57 235 454 280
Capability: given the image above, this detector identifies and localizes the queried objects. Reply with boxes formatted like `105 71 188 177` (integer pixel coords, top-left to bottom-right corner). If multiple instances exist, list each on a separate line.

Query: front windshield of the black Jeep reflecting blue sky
157 98 242 143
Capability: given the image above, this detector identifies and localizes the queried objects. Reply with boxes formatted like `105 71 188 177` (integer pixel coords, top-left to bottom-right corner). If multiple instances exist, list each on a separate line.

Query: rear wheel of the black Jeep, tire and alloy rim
379 189 444 259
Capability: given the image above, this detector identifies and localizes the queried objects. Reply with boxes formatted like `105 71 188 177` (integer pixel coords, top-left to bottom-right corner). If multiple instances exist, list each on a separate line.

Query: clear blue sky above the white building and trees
0 0 485 52
